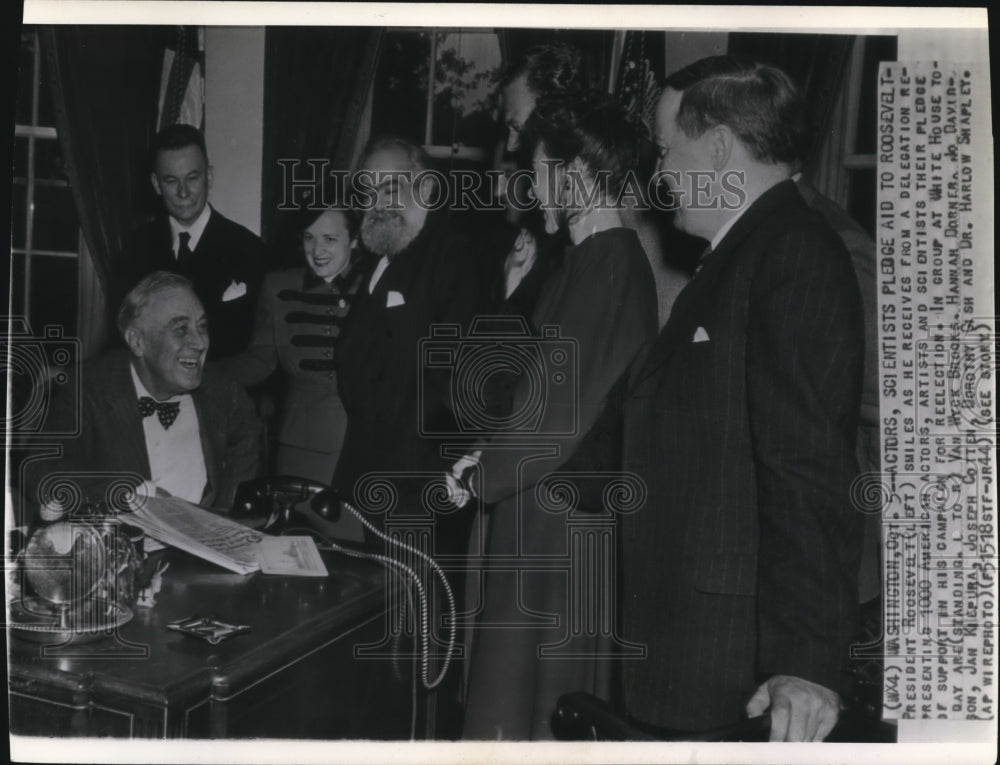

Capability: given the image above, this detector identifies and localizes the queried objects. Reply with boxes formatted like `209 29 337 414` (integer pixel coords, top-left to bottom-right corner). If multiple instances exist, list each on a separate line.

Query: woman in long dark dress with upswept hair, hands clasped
458 95 657 739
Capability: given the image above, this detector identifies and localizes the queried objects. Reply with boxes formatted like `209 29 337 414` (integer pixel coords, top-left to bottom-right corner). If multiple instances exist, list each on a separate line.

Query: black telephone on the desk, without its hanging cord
233 475 348 540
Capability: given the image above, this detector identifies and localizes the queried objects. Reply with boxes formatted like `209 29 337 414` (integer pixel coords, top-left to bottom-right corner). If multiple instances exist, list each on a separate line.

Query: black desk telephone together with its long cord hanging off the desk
233 475 457 690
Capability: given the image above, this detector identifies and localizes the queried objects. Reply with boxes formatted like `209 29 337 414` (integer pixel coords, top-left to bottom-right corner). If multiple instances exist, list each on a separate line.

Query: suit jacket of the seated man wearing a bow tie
28 349 261 509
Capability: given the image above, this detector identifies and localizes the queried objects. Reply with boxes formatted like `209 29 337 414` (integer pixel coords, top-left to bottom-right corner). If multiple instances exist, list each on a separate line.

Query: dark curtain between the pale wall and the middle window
261 27 383 262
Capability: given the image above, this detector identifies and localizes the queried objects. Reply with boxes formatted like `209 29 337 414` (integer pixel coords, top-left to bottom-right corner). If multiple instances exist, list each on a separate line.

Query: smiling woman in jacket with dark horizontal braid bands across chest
219 209 365 492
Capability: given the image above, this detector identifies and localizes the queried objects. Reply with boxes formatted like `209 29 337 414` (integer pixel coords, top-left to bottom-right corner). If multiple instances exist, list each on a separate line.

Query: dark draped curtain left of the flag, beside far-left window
39 26 163 354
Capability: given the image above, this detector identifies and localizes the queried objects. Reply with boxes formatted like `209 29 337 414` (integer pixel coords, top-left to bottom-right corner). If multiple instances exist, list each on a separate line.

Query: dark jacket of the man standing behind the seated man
112 209 267 359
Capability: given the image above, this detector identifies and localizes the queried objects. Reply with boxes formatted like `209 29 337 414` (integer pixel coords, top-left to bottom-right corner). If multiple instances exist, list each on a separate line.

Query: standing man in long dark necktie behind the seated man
113 125 267 359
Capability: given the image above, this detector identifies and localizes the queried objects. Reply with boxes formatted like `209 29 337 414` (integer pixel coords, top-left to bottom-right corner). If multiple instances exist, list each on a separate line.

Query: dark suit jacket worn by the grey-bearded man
334 213 483 496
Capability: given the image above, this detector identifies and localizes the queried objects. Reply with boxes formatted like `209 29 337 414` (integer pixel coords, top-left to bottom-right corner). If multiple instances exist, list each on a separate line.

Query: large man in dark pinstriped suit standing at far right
621 57 864 741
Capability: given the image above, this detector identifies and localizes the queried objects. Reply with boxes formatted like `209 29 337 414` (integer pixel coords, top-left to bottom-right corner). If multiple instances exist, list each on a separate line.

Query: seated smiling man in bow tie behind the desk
30 271 262 510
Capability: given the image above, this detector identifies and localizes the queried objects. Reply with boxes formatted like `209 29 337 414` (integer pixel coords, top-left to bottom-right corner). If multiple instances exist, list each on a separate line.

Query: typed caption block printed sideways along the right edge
876 61 997 720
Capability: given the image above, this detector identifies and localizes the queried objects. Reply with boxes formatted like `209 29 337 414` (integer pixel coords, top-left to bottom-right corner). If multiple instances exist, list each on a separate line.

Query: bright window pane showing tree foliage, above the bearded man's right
431 32 501 148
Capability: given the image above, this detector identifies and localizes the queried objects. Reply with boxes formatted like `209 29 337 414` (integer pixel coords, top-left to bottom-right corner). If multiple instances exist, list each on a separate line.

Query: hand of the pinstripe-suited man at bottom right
746 675 840 741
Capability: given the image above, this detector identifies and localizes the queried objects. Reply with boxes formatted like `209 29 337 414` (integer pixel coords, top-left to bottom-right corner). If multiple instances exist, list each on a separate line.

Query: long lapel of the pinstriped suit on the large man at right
634 180 797 384
